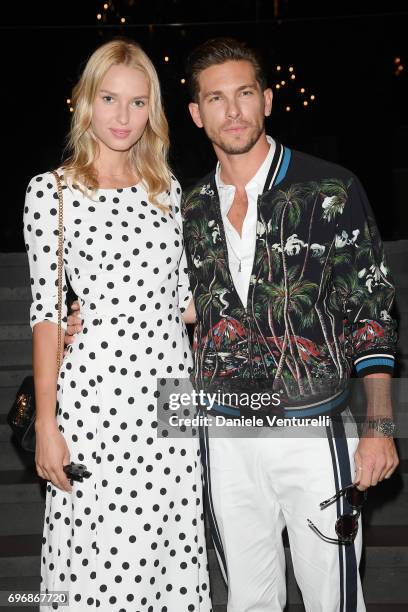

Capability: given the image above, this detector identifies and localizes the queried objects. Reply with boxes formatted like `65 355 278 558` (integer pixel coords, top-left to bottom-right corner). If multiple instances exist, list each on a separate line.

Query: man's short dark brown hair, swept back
186 37 267 102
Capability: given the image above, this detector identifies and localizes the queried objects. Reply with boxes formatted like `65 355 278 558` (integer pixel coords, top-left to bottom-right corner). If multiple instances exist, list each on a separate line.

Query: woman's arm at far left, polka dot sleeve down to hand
24 173 71 491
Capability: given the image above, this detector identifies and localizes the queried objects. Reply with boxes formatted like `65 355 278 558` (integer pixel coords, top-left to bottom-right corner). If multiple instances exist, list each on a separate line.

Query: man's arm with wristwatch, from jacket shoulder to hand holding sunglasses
334 177 398 490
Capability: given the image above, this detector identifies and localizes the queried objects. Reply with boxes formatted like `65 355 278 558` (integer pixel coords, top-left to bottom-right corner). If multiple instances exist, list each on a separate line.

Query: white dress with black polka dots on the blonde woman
24 171 211 612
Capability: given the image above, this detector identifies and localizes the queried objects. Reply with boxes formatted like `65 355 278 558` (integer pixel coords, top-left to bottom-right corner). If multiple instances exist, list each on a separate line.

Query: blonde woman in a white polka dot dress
24 40 211 612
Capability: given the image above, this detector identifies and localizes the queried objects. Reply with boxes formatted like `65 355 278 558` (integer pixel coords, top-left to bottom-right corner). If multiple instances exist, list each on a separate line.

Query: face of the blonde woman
91 64 149 152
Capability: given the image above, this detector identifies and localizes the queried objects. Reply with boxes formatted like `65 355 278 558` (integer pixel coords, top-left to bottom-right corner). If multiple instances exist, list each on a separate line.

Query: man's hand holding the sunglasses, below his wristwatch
353 433 399 491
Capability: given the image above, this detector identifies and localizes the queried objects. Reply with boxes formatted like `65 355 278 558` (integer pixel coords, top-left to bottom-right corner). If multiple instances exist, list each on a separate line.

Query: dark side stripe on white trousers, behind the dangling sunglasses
327 415 358 612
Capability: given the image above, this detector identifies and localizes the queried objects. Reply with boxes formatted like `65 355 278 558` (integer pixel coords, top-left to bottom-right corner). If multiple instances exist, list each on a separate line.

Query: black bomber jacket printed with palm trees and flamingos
182 143 396 416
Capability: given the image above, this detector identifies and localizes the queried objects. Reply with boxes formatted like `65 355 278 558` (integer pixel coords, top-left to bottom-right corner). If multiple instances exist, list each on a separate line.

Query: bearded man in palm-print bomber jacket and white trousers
183 39 398 612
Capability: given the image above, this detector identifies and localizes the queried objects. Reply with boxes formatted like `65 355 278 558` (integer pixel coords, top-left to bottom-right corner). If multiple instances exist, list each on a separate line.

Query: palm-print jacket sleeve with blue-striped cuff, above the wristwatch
335 177 397 377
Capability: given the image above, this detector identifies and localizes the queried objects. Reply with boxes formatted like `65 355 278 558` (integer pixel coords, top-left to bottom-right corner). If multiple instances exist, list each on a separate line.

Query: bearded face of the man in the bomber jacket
189 60 272 155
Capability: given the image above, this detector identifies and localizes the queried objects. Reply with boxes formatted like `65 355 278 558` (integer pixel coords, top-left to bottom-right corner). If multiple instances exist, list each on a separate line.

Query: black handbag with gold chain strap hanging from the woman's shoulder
7 170 64 452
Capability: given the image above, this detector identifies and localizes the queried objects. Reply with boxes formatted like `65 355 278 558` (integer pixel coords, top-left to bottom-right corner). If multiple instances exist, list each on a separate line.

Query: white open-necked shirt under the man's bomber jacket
215 136 276 307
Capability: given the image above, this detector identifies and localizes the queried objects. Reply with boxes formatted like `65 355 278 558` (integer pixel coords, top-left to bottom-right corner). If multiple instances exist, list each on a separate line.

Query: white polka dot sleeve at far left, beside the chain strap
23 172 67 328
